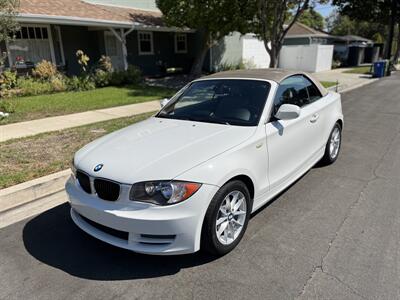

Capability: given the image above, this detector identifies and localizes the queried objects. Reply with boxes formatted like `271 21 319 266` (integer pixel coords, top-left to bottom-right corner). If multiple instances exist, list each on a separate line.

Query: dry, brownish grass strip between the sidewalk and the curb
0 113 152 189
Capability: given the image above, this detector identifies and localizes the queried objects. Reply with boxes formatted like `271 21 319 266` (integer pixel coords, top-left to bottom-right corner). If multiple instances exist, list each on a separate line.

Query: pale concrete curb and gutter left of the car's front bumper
0 169 71 228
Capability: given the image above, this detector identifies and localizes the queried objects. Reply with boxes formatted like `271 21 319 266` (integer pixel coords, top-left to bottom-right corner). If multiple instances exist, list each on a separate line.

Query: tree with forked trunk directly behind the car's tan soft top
249 0 328 68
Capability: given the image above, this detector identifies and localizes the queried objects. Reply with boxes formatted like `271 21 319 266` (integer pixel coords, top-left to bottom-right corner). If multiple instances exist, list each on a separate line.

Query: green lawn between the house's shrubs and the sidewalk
0 86 174 125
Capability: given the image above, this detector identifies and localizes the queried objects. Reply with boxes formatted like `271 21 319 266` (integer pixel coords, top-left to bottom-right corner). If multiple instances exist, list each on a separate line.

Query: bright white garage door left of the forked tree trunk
243 35 270 68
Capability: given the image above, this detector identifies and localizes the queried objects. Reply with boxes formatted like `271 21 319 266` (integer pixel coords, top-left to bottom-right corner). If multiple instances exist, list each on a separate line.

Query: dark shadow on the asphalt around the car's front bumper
23 204 215 280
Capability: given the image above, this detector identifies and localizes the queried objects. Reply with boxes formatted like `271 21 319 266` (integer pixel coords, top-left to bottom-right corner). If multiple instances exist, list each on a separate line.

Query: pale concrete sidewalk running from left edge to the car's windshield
0 100 160 142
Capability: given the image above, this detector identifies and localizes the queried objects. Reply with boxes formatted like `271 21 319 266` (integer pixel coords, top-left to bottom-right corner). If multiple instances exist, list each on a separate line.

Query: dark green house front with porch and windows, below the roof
5 23 198 76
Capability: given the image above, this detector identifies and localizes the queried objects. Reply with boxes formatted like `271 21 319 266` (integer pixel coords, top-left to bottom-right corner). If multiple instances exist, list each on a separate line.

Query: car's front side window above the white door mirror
273 75 309 113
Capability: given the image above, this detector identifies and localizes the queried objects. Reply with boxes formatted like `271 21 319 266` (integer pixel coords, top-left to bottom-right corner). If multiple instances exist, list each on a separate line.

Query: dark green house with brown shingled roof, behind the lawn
0 0 203 75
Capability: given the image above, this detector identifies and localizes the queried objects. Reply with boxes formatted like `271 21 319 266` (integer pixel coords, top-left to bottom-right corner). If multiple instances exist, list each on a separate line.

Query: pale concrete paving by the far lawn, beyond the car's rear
313 68 377 92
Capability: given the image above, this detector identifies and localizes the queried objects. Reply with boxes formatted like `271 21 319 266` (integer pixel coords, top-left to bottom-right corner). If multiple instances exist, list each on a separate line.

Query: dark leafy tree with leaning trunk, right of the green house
156 0 250 77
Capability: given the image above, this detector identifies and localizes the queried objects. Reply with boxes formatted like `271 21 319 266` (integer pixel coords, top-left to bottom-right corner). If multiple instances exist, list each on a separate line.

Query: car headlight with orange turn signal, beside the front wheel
129 181 201 205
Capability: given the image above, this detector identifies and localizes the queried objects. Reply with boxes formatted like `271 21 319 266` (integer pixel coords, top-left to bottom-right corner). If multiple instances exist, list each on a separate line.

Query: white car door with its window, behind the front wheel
265 75 318 190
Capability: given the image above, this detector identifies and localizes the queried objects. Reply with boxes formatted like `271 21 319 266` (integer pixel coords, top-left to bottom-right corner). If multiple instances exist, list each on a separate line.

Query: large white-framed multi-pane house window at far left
8 25 54 65
